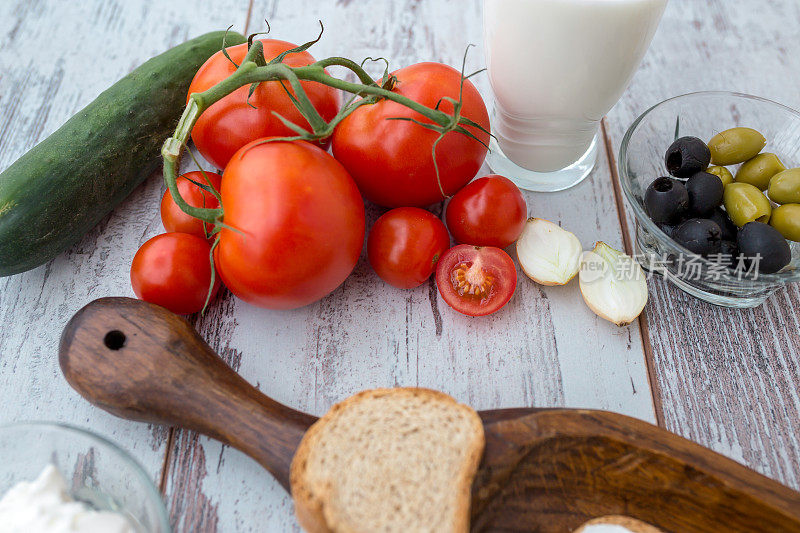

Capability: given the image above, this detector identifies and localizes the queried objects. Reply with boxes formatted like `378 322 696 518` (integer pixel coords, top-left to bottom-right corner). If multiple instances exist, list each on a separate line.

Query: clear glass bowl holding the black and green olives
617 91 800 308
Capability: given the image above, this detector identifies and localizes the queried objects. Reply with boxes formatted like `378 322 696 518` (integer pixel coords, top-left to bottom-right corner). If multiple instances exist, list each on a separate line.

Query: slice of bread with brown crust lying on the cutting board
290 388 484 533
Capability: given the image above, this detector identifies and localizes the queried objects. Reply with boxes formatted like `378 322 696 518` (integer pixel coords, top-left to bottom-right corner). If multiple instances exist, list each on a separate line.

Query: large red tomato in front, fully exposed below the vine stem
215 141 364 309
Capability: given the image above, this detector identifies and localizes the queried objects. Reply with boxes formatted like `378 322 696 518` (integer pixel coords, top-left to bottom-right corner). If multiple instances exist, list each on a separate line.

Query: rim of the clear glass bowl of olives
617 91 800 285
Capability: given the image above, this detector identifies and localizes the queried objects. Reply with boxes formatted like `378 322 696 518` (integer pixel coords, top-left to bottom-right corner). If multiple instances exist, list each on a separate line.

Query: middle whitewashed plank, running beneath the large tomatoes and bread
159 0 654 531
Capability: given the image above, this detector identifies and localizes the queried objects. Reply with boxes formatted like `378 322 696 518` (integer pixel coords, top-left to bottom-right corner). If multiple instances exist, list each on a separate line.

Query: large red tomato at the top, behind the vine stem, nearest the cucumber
187 39 339 168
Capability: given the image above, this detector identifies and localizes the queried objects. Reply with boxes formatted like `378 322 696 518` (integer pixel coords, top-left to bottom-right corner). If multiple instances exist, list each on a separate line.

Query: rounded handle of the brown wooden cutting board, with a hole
59 298 316 490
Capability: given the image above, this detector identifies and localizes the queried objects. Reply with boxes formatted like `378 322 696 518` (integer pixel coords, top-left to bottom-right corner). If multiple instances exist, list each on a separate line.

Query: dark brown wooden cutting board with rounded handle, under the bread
59 298 800 533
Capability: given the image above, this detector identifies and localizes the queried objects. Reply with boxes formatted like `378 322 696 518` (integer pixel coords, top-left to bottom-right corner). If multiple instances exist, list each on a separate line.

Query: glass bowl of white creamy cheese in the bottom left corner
0 422 170 533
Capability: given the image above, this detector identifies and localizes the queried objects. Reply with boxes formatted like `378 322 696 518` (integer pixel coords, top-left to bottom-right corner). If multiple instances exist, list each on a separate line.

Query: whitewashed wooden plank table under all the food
0 0 800 532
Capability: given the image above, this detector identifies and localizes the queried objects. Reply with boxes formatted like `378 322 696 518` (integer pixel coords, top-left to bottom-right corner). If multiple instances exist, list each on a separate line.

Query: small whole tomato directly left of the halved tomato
367 207 450 289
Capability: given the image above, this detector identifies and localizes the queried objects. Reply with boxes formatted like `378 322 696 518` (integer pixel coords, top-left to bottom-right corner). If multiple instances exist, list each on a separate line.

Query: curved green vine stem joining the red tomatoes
161 41 488 224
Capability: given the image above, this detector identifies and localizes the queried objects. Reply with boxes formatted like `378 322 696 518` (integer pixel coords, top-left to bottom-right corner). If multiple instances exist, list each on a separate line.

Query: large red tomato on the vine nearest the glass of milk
331 63 489 207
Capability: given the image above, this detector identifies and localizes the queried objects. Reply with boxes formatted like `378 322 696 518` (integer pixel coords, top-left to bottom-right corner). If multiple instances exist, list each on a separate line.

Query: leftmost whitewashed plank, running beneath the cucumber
0 0 247 500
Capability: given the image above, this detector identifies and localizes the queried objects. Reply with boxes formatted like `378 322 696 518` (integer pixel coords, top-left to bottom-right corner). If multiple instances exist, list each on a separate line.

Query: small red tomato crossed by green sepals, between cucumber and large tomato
161 171 222 239
